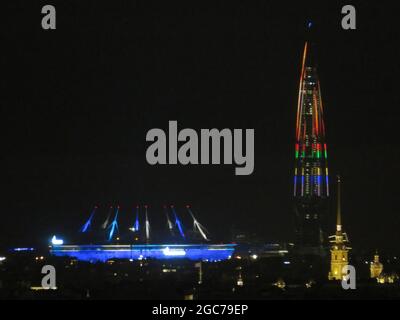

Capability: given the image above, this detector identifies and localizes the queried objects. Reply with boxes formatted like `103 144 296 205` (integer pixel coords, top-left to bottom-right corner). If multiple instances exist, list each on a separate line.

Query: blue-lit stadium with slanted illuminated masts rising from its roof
50 205 235 262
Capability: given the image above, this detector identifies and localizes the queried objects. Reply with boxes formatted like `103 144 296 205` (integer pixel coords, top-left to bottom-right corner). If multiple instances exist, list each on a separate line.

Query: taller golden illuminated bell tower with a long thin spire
328 176 350 280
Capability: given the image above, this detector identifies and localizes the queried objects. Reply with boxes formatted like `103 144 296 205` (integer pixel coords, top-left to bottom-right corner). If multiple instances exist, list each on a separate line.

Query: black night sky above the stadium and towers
0 0 400 249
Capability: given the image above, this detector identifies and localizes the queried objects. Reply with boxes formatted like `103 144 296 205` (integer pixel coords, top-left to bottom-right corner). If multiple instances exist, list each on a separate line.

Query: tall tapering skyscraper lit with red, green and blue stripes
293 42 329 251
